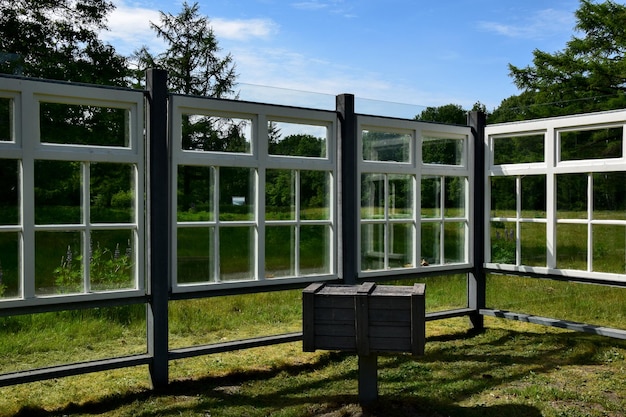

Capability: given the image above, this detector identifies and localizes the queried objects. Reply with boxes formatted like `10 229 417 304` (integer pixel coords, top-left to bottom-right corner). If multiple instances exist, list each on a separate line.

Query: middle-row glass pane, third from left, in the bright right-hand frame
556 174 588 219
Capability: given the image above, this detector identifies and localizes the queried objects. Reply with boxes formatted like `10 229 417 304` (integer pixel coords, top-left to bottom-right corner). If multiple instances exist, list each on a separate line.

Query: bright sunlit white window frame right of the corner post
484 110 626 282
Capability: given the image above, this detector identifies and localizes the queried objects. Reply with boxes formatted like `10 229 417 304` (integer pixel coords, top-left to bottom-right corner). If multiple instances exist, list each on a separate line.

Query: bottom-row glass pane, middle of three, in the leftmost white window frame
35 232 84 295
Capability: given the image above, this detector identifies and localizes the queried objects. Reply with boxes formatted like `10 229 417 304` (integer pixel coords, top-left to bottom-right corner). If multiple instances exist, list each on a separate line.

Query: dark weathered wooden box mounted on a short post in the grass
302 282 426 355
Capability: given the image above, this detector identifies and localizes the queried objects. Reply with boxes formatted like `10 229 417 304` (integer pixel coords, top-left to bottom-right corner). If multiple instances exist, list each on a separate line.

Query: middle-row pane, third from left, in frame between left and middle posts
265 169 296 220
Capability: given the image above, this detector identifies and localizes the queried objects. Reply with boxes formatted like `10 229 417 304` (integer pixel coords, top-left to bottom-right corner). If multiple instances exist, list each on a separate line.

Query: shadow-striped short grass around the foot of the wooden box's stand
17 329 626 417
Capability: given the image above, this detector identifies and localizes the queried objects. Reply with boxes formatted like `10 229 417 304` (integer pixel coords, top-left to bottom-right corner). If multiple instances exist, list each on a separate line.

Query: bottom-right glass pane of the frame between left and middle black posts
300 225 331 275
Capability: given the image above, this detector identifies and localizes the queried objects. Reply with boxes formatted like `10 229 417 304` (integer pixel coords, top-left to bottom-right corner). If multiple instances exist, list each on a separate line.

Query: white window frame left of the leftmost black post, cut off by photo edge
0 78 146 308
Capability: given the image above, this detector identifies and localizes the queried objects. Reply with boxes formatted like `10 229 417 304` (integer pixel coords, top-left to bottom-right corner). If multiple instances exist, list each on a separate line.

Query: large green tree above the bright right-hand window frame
509 0 626 118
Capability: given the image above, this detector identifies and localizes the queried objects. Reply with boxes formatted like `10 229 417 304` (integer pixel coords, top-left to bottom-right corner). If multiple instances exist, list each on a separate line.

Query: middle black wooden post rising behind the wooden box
336 94 359 285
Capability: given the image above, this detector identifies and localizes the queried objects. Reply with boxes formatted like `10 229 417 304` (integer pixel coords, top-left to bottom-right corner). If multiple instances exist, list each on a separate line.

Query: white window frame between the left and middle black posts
170 95 338 293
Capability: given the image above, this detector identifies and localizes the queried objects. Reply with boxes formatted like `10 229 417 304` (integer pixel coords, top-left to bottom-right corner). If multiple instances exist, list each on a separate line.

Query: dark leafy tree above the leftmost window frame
0 0 128 86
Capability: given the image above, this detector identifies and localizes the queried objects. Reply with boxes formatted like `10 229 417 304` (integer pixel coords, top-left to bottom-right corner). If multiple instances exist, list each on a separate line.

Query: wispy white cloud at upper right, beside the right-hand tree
478 9 575 39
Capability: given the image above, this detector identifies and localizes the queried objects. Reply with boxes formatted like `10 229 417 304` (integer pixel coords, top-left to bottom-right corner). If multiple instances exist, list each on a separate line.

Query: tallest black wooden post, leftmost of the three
146 69 170 390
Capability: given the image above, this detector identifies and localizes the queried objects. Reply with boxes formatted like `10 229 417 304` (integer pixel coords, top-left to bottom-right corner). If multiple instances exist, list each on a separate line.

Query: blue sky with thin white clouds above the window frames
102 0 579 117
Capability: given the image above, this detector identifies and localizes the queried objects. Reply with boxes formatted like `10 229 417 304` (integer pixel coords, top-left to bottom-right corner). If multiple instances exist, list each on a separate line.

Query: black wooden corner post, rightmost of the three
467 111 488 331
